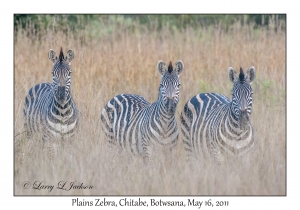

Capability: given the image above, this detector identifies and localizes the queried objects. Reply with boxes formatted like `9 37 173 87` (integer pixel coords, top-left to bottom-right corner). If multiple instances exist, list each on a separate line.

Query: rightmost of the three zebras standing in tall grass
180 66 255 163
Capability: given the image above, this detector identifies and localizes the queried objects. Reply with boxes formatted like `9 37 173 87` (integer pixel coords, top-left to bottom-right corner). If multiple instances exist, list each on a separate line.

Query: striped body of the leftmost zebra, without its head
24 83 78 140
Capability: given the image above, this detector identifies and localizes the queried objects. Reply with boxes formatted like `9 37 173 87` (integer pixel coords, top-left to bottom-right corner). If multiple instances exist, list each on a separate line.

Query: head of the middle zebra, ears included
157 60 184 114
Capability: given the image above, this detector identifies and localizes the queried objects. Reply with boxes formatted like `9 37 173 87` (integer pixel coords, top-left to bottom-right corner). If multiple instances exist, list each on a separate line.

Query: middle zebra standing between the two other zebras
100 60 184 163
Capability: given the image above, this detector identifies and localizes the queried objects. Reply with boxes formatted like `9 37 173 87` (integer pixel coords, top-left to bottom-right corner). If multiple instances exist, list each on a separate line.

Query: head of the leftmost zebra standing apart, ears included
48 48 74 104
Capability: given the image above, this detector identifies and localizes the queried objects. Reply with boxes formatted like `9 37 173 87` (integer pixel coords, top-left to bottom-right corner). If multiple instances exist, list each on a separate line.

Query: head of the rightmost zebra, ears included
228 66 255 130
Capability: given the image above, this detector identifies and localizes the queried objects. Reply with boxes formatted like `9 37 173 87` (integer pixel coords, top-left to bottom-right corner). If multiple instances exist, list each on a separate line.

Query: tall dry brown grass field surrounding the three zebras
14 18 286 196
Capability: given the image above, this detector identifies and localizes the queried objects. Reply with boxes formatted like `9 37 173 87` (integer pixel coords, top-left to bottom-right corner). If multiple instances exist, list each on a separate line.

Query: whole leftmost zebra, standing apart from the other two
24 48 79 154
